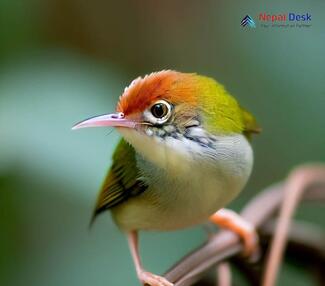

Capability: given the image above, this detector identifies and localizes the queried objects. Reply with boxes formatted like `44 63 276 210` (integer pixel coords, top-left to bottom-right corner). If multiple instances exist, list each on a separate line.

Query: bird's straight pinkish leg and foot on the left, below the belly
128 231 174 286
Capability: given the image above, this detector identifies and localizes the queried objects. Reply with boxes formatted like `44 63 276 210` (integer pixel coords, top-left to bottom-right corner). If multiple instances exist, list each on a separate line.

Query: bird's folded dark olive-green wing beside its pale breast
93 139 147 220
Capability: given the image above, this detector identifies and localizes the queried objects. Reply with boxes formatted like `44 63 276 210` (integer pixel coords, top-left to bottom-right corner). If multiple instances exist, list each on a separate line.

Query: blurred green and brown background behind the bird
0 0 325 286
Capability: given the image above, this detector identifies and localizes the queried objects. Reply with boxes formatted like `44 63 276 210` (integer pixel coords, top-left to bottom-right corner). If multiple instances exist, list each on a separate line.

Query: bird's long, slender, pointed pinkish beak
72 112 136 130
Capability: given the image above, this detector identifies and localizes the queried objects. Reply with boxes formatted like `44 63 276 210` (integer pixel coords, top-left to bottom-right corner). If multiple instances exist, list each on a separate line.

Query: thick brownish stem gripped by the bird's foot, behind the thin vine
165 164 325 286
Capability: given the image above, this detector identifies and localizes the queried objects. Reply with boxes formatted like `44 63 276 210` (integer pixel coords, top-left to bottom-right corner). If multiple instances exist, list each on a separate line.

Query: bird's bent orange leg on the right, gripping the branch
210 209 258 256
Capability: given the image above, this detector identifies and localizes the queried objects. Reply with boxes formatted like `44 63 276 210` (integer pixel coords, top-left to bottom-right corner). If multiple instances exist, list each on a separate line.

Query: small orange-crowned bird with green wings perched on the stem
73 70 261 286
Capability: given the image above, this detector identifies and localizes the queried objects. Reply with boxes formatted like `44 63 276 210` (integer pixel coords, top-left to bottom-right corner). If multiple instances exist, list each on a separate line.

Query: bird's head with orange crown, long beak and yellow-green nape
74 70 257 166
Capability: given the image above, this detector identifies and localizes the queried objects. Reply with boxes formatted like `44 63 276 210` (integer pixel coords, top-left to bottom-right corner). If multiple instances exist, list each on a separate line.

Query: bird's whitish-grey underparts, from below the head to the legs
113 129 253 230
